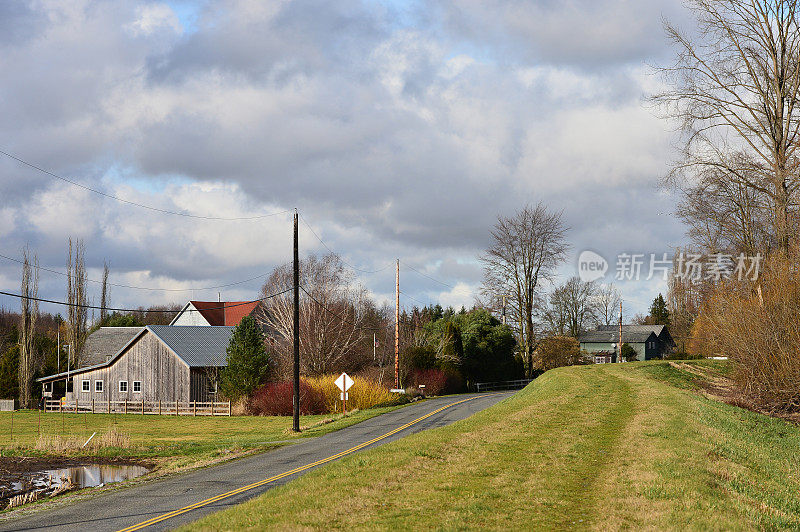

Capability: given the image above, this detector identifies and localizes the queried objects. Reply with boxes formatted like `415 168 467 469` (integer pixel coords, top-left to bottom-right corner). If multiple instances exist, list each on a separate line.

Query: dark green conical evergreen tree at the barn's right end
220 316 270 401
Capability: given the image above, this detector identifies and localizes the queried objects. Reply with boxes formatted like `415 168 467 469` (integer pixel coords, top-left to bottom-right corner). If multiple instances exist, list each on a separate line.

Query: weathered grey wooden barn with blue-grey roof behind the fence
38 325 234 404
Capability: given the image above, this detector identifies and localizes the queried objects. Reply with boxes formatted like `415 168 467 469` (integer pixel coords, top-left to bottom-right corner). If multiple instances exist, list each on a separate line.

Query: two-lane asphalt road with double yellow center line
0 392 510 531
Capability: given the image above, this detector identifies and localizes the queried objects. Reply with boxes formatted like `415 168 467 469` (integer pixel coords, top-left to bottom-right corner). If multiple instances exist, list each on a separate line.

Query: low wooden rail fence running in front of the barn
44 399 231 416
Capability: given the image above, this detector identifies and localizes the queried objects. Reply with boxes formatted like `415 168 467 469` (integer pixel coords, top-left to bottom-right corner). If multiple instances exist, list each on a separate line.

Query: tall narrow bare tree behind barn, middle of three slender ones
67 238 88 366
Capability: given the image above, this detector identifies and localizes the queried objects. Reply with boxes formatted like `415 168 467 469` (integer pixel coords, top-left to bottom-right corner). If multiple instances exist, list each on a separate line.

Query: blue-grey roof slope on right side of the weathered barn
147 325 235 367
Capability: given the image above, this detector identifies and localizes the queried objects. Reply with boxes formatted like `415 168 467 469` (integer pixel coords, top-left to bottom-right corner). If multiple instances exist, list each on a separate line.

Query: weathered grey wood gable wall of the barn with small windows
72 331 193 403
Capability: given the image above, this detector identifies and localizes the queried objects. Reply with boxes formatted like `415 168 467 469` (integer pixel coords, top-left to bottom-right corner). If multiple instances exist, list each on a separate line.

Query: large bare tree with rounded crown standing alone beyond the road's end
480 203 569 375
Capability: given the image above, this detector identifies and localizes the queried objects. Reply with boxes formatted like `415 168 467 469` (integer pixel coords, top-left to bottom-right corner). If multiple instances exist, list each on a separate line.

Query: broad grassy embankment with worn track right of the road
188 361 800 530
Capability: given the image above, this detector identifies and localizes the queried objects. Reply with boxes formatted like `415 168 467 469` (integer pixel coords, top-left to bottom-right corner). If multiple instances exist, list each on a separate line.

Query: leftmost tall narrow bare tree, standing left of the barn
19 247 39 408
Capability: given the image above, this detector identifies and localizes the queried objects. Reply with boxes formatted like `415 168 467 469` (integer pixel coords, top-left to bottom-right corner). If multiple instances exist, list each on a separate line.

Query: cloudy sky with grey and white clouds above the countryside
0 0 690 312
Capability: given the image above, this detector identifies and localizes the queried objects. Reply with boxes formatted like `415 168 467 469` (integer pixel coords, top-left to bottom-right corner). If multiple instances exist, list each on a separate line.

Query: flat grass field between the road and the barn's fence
0 407 394 464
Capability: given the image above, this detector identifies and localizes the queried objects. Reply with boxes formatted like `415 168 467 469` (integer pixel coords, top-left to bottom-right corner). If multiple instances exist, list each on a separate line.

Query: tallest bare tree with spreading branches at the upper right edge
654 0 800 249
